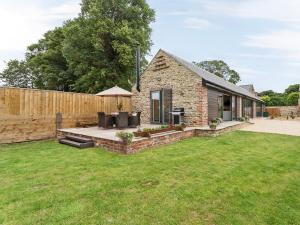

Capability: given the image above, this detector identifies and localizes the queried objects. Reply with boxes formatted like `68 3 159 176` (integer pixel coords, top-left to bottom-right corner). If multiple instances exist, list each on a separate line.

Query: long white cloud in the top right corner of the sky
204 0 300 22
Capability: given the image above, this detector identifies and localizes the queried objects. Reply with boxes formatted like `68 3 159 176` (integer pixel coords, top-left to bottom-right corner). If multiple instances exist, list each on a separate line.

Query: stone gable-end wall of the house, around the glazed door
132 50 208 126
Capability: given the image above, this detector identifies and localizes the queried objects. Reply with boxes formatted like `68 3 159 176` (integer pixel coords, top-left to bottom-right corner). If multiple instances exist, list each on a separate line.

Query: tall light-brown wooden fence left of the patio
0 87 132 143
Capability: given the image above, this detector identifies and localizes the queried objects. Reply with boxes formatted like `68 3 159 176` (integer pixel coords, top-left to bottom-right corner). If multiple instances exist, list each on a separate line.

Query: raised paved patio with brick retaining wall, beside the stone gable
57 121 248 154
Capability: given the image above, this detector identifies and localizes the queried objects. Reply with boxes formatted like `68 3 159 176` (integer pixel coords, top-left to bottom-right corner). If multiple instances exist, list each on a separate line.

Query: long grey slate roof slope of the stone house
161 49 261 101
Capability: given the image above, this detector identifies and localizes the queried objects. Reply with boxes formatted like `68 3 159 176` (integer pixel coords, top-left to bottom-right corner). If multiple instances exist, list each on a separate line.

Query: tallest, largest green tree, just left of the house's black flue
63 0 154 93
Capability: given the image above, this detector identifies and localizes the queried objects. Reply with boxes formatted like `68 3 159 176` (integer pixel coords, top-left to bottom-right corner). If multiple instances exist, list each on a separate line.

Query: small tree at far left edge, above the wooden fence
0 59 34 88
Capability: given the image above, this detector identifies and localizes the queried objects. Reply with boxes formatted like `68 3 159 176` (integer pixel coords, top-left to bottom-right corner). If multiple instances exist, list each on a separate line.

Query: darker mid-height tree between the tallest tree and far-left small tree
26 27 76 91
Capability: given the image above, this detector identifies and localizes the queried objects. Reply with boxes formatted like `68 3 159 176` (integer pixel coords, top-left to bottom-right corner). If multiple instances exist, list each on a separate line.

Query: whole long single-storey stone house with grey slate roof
132 50 263 126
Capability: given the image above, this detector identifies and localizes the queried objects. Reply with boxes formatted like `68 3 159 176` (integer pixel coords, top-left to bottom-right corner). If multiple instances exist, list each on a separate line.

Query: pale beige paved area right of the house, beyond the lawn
241 118 300 136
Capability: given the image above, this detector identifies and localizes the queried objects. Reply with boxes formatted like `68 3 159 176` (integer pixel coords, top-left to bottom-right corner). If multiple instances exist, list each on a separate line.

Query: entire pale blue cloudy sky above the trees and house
0 0 300 91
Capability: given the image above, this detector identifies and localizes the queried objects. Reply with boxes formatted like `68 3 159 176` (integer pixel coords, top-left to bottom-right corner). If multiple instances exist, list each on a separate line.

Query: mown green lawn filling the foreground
0 131 300 225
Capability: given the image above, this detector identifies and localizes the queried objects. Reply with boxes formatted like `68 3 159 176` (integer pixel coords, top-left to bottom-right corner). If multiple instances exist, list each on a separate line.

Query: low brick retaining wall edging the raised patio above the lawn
57 123 248 154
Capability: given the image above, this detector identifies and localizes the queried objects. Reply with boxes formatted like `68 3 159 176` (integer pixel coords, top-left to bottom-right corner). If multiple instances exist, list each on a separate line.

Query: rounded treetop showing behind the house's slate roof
195 60 241 84
